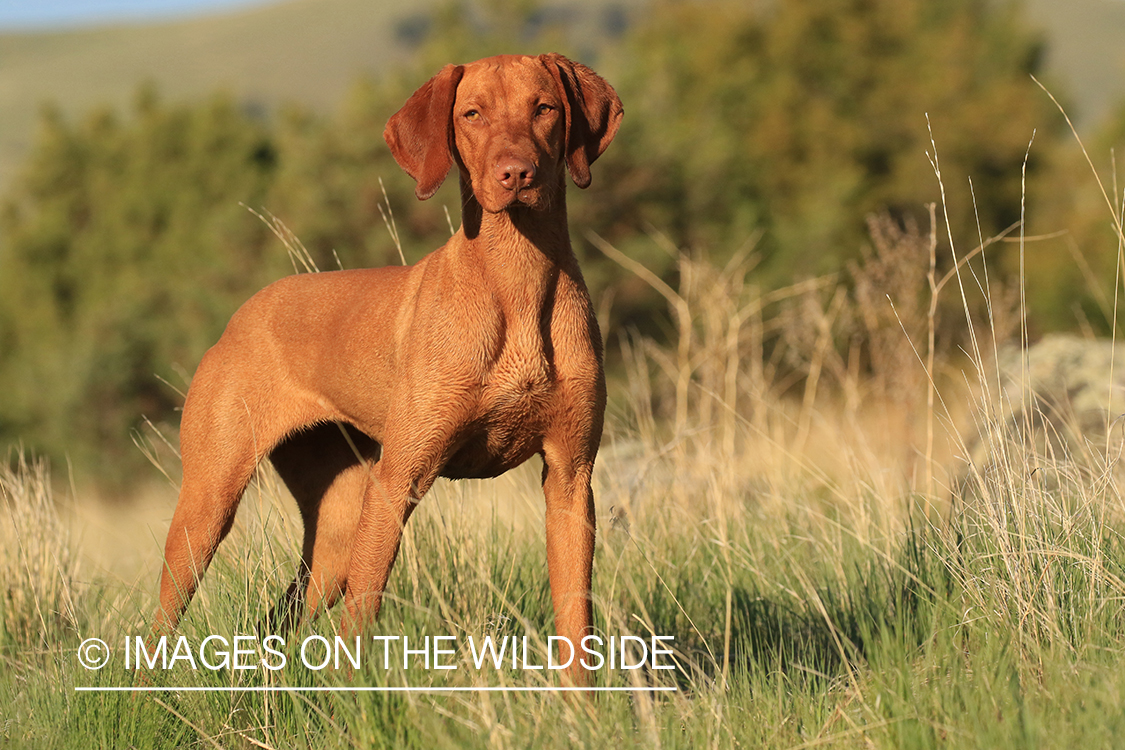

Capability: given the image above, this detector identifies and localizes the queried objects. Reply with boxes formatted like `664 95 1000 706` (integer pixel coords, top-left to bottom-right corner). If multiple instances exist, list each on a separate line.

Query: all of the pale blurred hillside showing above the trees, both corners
0 0 1125 190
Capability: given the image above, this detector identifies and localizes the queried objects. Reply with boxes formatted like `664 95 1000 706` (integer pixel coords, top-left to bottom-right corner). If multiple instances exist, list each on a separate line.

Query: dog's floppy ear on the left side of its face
383 65 465 200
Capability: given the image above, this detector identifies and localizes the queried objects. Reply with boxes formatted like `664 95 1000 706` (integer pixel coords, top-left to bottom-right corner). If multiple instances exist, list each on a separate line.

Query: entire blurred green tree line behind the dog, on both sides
0 0 1098 488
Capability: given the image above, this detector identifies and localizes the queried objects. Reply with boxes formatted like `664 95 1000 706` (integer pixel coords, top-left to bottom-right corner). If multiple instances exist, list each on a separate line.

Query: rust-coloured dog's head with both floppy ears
384 53 623 213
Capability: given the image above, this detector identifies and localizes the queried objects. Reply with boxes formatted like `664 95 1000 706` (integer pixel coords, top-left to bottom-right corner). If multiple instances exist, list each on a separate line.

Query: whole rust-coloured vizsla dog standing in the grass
156 54 622 683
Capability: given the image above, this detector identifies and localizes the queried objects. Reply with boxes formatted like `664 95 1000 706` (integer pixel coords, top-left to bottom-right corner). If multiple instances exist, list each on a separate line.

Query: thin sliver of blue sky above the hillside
0 0 268 29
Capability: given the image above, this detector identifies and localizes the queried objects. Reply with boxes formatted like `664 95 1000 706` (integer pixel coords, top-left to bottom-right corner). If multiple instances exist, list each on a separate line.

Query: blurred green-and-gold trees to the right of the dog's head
602 0 1058 290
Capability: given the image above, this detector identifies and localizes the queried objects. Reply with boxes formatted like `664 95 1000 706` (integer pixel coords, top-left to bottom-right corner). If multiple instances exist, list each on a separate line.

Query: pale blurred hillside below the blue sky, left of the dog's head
0 0 423 184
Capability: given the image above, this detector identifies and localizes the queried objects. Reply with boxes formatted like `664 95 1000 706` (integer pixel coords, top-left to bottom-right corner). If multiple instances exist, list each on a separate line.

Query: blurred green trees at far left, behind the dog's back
0 89 288 488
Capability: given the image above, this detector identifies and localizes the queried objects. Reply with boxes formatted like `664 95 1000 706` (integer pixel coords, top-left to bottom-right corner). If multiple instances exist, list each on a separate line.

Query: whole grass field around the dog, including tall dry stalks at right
0 178 1125 750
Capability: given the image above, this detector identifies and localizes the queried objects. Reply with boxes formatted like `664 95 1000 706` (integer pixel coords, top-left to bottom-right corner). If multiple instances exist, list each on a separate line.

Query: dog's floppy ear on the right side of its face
539 53 624 188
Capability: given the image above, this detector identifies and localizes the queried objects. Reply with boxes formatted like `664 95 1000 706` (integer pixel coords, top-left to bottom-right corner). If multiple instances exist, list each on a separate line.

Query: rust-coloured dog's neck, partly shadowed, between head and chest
461 178 575 313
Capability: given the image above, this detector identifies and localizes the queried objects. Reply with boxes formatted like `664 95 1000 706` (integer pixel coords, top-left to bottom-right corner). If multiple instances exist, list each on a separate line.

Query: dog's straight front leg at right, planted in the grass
543 443 595 685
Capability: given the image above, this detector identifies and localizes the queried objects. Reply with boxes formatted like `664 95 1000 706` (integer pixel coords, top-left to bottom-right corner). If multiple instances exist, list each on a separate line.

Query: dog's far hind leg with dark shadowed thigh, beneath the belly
270 423 379 633
